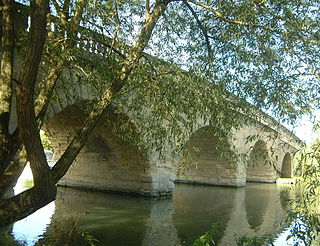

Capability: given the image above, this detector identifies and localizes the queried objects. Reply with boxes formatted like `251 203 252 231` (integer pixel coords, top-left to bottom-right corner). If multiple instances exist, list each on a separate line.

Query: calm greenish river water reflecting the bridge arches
12 165 296 246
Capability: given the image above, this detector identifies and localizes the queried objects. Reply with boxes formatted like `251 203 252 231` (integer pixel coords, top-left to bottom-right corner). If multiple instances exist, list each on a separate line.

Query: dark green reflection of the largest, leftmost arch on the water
39 189 150 245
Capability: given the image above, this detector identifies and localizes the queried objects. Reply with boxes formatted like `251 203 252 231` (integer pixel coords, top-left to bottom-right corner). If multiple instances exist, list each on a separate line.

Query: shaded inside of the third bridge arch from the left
247 140 276 182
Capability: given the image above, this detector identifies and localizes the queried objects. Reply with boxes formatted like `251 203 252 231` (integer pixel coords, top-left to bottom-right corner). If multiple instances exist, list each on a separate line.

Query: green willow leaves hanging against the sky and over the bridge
55 1 319 164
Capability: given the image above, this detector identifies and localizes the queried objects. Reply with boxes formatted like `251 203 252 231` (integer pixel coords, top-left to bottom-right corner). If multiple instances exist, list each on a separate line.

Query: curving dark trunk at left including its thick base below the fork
0 0 56 226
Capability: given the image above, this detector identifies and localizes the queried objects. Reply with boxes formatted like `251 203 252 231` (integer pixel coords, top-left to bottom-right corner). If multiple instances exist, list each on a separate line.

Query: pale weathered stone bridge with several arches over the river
6 2 302 196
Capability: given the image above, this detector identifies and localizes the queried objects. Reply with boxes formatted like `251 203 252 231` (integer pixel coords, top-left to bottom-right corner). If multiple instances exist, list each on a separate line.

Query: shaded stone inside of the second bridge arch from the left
176 126 237 185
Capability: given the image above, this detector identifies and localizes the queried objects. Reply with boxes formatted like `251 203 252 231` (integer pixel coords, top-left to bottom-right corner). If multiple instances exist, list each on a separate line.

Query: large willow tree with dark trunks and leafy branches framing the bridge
0 0 320 228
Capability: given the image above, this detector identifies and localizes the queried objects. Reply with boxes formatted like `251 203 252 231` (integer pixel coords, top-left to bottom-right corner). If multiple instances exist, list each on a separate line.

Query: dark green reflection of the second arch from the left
173 185 236 245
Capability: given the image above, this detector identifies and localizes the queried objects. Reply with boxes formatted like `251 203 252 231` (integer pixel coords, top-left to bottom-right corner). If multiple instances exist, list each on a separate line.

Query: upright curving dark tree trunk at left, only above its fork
17 0 55 197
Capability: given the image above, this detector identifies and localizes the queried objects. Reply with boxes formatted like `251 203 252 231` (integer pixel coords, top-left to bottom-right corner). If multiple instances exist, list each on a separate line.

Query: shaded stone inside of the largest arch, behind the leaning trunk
44 102 151 195
